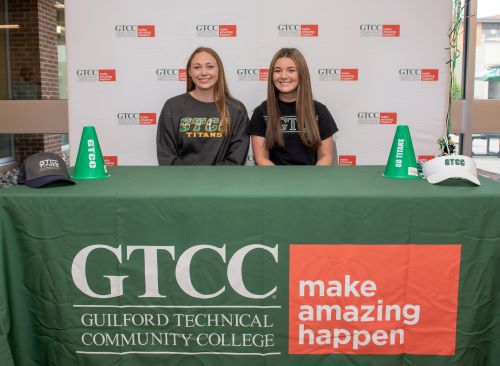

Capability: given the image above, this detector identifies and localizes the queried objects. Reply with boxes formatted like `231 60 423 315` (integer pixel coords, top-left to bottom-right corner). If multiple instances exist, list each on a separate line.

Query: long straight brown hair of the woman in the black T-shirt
266 48 321 149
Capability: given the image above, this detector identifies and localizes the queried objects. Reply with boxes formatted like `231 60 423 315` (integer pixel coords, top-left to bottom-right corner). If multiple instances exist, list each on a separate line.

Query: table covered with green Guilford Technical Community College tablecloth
0 166 500 366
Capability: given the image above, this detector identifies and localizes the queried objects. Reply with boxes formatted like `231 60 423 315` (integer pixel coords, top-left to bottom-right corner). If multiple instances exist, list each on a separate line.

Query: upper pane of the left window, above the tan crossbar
0 0 68 100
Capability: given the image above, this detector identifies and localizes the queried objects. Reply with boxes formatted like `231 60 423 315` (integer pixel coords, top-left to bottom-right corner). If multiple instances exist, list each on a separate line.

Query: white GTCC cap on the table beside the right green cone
423 155 481 186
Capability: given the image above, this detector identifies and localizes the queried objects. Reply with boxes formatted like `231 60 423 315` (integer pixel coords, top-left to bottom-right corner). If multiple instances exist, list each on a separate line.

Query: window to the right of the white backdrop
452 0 500 174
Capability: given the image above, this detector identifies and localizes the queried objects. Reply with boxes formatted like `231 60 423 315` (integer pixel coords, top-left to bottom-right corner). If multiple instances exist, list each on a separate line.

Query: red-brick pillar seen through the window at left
8 0 61 166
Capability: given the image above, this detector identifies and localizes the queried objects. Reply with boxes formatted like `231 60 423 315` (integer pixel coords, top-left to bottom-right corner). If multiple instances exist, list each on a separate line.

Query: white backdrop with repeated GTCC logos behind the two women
66 0 451 165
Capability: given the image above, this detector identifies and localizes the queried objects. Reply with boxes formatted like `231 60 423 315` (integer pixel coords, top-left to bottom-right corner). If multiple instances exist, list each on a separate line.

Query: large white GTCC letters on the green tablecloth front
71 244 278 299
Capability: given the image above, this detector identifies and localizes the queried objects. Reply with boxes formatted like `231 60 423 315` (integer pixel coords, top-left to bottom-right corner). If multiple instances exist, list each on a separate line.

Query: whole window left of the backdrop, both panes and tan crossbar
0 0 67 164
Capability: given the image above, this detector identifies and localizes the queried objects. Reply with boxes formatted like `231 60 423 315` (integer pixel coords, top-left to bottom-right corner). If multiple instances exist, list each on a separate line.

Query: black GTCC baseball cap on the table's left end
18 152 75 188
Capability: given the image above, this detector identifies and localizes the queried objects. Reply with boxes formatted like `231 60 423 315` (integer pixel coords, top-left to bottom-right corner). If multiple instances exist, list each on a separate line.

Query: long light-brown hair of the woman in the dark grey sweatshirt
186 47 233 135
